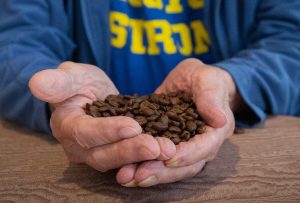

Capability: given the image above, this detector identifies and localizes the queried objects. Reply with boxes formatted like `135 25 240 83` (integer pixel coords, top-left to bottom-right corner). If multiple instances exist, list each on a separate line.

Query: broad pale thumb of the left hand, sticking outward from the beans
29 62 118 103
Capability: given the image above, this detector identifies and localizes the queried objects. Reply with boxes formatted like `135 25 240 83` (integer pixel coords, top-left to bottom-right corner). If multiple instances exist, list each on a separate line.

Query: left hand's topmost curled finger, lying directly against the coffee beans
50 102 142 149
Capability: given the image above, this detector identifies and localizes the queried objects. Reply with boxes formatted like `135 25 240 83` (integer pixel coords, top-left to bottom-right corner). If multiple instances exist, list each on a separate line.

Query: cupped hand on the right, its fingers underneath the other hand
117 59 237 187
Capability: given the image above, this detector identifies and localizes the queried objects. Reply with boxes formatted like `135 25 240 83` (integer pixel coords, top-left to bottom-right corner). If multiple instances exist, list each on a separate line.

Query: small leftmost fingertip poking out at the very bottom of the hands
116 164 138 187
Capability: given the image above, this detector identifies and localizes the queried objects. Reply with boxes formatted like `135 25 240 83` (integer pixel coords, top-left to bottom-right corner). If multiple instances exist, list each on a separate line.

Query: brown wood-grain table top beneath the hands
0 117 300 202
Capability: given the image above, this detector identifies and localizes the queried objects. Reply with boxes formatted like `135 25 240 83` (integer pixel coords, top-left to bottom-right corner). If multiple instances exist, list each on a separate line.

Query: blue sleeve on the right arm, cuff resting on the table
215 0 300 127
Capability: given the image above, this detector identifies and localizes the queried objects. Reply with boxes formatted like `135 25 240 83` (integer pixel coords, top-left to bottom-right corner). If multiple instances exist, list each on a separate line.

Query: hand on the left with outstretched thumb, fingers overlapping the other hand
29 62 176 176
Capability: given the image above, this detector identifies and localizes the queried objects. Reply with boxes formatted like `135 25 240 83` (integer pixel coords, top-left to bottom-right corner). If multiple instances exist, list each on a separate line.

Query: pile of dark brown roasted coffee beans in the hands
85 92 205 144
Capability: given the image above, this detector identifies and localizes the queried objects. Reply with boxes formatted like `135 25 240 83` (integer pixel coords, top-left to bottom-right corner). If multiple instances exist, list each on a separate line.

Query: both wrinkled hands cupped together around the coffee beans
29 59 237 187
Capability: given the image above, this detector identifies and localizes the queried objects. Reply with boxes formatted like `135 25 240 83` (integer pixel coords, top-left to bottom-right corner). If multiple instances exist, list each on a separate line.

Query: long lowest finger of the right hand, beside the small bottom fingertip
134 161 205 187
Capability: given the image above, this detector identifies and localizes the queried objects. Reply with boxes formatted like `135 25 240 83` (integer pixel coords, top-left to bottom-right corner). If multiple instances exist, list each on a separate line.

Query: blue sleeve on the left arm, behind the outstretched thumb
0 0 74 133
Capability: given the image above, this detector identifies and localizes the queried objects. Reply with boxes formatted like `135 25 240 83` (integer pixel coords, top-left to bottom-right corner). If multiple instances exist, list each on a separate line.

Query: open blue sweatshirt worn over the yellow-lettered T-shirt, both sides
0 0 300 133
